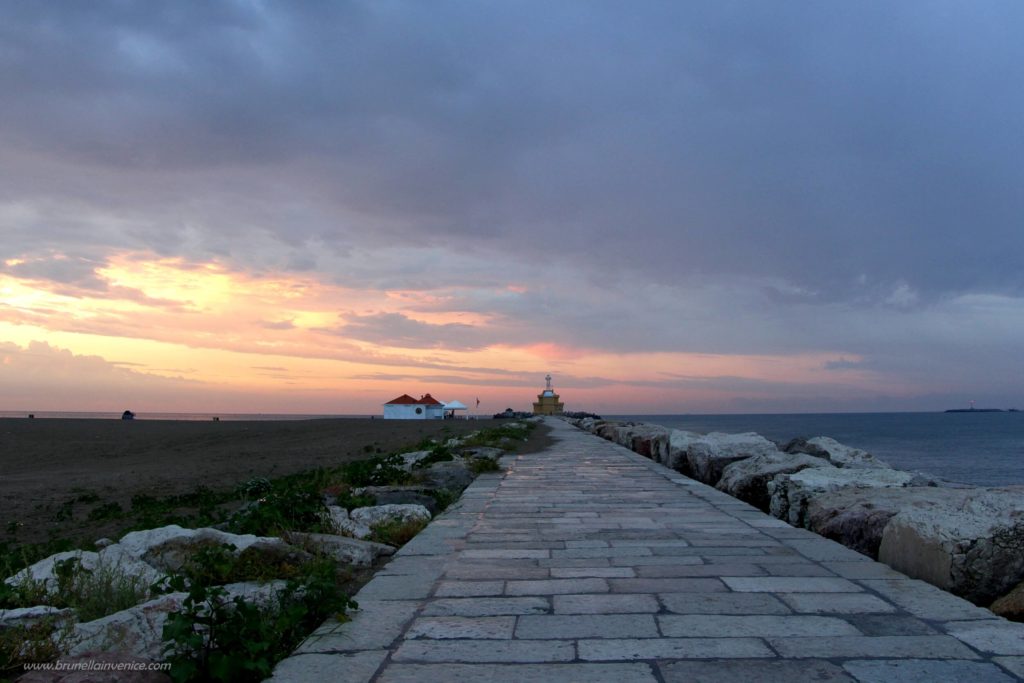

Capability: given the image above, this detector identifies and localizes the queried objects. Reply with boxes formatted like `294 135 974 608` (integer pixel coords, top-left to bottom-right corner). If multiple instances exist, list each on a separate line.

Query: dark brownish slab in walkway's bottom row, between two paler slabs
657 659 854 683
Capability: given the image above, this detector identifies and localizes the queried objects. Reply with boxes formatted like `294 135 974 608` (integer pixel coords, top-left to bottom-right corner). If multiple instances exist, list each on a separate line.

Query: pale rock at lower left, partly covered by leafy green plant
61 581 286 661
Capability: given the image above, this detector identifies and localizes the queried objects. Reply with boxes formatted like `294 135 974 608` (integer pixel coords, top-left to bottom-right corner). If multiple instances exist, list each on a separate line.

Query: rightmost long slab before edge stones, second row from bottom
768 636 978 659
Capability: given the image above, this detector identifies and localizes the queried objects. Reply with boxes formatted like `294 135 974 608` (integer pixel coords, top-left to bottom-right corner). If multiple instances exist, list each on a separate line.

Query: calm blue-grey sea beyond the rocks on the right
605 413 1024 486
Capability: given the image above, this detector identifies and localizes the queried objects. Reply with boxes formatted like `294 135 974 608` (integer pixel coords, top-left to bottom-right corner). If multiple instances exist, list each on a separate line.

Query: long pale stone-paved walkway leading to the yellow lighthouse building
273 420 1024 683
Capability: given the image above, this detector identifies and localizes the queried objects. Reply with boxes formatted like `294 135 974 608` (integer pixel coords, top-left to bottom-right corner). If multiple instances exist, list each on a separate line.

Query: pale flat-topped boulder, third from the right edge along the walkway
768 466 913 526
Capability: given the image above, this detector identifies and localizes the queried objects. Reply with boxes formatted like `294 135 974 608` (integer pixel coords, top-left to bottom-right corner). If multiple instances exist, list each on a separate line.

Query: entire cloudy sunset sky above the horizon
0 0 1024 415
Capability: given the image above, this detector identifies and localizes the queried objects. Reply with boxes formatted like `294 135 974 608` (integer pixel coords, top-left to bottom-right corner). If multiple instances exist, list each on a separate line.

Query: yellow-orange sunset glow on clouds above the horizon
0 253 888 414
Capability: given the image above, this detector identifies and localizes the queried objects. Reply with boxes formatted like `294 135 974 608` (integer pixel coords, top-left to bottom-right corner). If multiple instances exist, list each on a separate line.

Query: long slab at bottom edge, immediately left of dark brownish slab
377 663 657 683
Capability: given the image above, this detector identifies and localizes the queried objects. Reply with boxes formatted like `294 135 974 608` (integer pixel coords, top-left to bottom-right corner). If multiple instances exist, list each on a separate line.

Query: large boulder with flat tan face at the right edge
879 486 1024 605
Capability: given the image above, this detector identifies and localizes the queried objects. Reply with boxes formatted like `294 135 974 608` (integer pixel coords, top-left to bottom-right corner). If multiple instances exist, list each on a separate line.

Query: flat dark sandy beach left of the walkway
0 419 548 543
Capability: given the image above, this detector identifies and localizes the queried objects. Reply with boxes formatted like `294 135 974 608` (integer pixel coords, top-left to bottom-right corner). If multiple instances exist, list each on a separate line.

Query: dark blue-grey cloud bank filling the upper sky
0 2 1024 299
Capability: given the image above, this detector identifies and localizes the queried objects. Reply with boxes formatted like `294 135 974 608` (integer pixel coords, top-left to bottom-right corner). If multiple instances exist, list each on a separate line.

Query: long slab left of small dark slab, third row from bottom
657 614 860 638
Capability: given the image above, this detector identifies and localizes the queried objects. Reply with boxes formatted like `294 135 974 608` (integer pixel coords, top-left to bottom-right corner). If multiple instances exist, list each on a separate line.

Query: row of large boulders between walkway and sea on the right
569 419 1024 621
